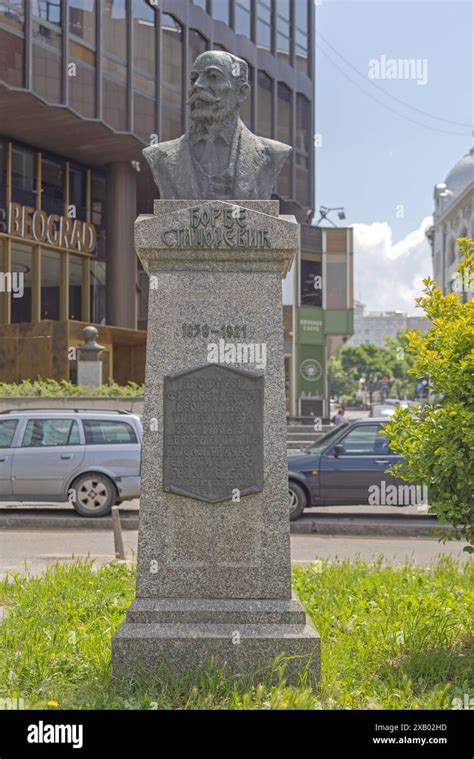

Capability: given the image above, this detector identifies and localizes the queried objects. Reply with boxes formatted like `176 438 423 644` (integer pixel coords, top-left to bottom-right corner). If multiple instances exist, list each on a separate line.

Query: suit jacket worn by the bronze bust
143 119 292 200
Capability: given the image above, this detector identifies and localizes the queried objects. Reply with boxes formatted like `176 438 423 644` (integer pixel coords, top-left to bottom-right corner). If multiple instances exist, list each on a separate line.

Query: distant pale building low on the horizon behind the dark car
347 302 431 348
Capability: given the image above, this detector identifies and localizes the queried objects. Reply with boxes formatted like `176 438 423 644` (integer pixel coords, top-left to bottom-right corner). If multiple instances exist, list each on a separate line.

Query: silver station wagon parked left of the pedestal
0 408 142 517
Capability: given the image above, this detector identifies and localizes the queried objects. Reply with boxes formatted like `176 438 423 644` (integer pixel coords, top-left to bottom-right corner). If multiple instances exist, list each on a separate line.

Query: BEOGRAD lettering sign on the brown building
0 203 97 253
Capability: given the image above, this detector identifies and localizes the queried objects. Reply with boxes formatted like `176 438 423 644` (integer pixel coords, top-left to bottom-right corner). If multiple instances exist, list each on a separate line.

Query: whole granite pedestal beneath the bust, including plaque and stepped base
112 200 319 682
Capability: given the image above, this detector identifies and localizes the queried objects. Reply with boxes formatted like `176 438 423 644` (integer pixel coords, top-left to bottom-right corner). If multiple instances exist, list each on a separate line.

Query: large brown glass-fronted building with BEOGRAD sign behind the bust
0 0 314 383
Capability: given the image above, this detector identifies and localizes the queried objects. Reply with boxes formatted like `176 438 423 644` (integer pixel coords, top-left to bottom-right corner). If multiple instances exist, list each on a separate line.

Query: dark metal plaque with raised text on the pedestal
163 364 264 503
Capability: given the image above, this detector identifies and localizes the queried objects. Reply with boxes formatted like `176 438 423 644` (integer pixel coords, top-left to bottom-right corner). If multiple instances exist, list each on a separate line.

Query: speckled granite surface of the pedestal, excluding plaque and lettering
112 201 319 678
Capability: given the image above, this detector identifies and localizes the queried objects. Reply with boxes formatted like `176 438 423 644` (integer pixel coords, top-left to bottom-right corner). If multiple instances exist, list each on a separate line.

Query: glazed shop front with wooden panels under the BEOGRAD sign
0 140 145 384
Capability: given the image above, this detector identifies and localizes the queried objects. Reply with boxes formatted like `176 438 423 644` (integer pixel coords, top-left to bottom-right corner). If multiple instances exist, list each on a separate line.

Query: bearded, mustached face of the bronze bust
188 51 249 128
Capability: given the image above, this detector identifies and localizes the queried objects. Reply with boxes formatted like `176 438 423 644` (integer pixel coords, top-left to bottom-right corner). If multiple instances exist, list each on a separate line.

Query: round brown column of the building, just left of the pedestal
106 161 137 329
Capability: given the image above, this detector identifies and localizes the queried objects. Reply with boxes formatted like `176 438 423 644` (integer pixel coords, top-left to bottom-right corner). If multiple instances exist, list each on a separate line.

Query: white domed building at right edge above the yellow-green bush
427 148 474 299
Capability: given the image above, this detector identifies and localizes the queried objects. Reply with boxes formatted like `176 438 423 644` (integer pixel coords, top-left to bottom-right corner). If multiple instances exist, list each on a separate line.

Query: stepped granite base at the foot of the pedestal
112 597 320 685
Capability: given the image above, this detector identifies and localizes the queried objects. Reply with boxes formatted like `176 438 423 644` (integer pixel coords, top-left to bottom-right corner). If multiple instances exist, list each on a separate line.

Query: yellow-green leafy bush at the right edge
387 238 474 552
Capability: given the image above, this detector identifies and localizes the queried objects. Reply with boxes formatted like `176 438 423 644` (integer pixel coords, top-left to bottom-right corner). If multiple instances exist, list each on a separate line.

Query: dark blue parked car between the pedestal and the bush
288 418 403 520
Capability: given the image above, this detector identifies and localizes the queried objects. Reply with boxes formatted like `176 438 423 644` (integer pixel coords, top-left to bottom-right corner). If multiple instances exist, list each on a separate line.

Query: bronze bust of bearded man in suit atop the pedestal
143 50 292 200
